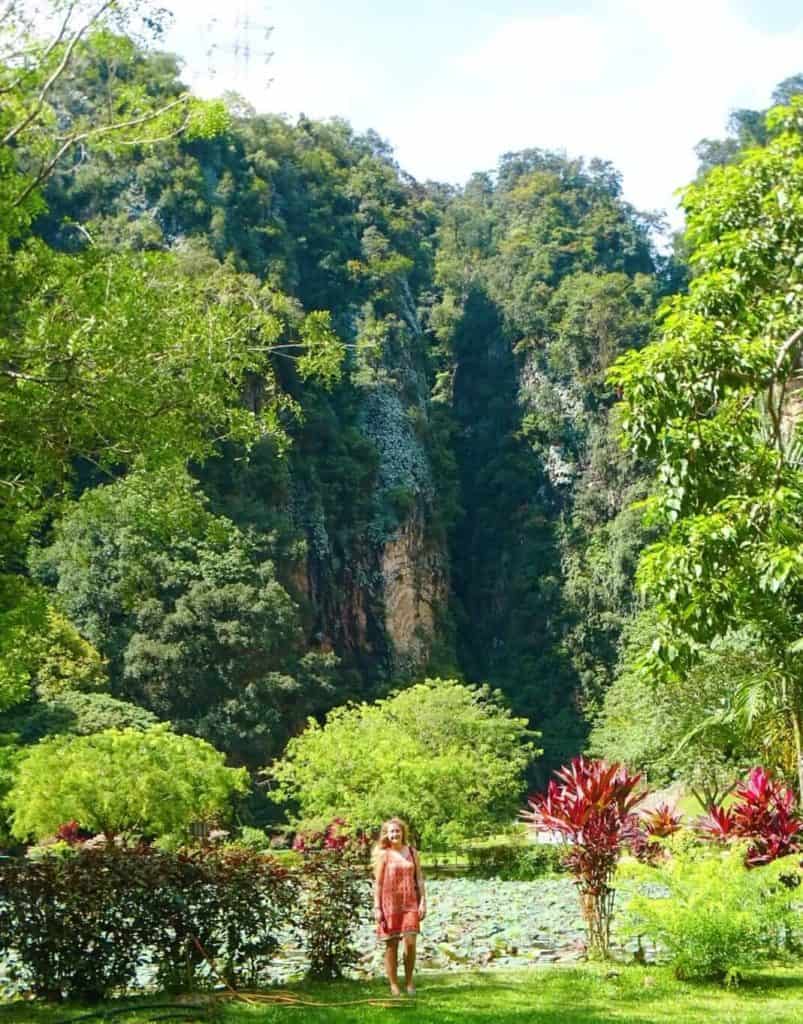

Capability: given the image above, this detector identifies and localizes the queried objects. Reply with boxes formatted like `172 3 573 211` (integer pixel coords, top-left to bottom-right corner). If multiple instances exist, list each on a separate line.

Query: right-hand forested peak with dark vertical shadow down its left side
431 150 657 769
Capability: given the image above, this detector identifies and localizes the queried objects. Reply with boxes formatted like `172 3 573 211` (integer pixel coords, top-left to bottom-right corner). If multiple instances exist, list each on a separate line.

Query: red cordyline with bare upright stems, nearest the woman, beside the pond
521 757 646 957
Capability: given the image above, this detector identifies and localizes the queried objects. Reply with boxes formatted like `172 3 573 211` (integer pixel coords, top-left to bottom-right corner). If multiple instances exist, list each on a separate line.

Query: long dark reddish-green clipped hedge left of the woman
0 844 297 1000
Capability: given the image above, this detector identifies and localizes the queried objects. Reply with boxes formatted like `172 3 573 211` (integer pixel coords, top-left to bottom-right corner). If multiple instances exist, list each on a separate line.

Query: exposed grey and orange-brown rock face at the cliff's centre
289 339 457 695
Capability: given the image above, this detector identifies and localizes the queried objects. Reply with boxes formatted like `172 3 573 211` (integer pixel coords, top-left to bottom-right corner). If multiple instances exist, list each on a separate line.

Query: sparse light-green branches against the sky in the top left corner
0 0 228 241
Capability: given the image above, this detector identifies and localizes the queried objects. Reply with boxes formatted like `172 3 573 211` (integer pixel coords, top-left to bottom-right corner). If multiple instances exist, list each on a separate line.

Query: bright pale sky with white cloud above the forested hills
159 0 803 228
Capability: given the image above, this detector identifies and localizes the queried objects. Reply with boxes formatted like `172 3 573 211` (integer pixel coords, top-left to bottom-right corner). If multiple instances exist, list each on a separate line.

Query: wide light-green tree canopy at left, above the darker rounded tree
0 235 340 557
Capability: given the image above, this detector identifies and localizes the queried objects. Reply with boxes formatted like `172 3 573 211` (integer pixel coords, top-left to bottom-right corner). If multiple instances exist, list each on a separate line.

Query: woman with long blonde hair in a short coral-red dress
373 818 426 995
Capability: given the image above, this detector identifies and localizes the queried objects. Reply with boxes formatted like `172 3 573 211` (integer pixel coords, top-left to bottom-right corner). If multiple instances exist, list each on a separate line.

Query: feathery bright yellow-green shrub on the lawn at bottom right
620 846 800 982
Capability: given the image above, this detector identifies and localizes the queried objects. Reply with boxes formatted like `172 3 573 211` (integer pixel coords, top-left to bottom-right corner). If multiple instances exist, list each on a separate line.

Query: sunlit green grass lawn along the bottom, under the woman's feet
0 966 803 1024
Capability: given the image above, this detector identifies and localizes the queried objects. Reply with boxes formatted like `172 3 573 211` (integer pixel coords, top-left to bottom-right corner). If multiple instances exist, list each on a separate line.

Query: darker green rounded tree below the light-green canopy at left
34 467 336 767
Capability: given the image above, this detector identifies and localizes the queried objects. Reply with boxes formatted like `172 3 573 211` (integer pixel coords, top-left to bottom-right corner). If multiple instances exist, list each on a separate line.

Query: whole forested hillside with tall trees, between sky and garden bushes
0 3 803 845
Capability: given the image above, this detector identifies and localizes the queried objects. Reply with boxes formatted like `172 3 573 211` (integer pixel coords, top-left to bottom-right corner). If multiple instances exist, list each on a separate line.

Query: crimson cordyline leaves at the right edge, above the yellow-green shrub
696 767 803 867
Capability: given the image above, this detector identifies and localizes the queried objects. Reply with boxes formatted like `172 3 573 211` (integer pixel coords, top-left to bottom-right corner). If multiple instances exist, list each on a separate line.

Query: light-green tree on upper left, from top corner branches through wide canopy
0 0 342 558
